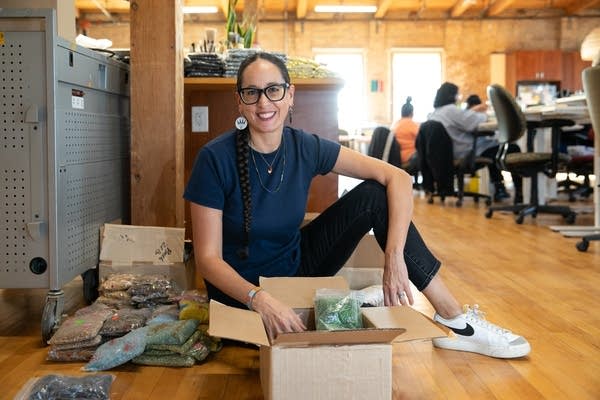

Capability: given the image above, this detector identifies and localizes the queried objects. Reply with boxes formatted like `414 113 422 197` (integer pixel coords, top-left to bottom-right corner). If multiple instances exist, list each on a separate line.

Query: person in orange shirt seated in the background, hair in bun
391 96 419 175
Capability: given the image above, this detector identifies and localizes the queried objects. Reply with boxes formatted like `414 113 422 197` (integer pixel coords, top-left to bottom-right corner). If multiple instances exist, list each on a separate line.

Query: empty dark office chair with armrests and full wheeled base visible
485 84 576 224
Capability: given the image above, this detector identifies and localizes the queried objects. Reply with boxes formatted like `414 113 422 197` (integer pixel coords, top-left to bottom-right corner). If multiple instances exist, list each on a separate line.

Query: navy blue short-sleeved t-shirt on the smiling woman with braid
184 127 340 303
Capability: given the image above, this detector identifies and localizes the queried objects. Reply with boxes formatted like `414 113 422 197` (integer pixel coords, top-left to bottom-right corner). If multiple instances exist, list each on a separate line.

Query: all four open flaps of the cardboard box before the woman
208 277 445 346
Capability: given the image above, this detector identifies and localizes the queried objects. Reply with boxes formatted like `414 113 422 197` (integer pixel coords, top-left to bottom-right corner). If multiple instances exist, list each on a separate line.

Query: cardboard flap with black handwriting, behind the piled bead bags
100 224 185 265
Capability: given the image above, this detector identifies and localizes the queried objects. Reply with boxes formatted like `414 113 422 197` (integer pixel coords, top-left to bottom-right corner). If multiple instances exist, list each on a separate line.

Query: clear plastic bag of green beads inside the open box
315 289 363 331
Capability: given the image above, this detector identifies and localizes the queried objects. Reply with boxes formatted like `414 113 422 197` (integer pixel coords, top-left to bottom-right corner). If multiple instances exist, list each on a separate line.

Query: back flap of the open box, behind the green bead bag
260 276 349 308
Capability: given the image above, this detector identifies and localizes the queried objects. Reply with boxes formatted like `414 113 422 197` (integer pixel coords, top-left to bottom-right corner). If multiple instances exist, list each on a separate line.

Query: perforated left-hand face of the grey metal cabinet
0 32 48 288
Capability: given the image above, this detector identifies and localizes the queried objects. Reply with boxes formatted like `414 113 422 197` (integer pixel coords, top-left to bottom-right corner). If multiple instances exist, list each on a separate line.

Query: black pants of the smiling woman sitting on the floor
297 181 441 290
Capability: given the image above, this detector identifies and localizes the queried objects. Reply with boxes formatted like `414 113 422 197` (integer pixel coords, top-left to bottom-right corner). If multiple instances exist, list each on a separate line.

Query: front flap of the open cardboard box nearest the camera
273 328 406 347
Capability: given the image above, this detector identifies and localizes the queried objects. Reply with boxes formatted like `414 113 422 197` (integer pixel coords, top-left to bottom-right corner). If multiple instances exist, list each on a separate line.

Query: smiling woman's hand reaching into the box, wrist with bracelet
252 290 306 340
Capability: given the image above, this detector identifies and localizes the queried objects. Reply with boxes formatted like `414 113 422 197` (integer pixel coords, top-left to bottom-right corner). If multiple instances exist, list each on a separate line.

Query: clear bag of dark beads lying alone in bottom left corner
14 374 115 400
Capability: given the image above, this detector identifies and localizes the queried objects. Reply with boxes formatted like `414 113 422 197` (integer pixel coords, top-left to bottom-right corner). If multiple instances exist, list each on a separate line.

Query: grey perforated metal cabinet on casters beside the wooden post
0 9 130 341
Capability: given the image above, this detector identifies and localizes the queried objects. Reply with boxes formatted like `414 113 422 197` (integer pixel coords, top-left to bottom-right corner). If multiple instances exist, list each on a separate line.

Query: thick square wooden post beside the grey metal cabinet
130 0 184 227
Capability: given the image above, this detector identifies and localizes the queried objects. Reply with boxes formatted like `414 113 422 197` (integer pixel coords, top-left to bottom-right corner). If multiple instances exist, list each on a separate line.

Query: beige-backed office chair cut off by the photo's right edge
575 65 600 251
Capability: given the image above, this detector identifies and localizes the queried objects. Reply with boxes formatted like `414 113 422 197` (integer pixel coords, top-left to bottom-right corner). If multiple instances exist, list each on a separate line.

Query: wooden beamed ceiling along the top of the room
75 0 600 22
